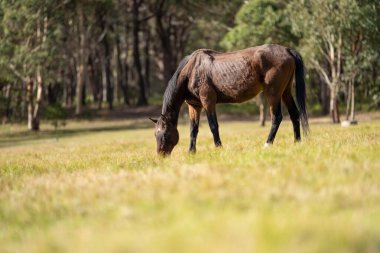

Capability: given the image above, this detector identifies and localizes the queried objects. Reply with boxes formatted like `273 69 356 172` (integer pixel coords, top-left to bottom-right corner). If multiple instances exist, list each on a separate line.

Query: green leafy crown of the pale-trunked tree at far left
0 0 60 79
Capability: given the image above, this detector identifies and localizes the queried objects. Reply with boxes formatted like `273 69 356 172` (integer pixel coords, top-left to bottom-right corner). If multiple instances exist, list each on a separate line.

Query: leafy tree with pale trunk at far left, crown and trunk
0 0 59 130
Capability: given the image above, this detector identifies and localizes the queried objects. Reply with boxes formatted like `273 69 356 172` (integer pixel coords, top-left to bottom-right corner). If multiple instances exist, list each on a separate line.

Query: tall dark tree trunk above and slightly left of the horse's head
133 0 148 105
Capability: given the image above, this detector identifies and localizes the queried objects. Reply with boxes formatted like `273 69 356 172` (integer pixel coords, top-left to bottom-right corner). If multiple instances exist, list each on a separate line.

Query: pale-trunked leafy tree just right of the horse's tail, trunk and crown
288 0 376 123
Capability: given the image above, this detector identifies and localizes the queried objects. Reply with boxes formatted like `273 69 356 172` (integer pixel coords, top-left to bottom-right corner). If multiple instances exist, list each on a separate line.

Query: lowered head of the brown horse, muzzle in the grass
151 115 179 156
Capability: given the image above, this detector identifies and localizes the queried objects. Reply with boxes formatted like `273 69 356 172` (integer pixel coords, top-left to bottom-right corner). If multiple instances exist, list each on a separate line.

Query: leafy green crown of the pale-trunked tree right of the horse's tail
289 0 380 90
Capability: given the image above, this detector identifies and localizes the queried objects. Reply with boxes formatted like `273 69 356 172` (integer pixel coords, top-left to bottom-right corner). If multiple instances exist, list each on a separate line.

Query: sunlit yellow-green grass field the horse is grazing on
0 117 380 253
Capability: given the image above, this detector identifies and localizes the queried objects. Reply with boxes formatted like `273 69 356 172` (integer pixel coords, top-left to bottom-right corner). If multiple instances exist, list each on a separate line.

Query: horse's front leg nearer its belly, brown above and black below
199 86 222 147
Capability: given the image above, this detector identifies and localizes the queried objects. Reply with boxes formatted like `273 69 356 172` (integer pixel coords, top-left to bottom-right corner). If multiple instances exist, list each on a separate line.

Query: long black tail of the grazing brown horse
288 49 309 135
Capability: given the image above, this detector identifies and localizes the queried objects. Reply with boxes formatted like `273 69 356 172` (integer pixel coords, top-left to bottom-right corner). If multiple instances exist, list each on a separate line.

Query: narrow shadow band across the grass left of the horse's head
0 121 153 148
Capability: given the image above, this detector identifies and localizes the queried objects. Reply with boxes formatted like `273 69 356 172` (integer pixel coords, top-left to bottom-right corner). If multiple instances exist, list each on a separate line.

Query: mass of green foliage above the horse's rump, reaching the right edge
221 0 380 118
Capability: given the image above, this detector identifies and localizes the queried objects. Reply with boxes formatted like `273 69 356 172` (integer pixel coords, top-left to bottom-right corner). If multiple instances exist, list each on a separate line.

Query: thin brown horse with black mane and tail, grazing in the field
152 45 308 155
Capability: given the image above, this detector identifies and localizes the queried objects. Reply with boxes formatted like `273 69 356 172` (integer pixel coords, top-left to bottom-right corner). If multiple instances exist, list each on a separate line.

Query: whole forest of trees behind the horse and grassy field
0 0 380 130
